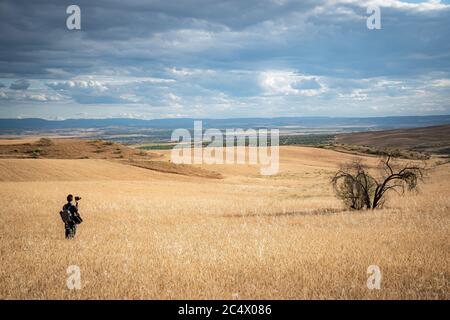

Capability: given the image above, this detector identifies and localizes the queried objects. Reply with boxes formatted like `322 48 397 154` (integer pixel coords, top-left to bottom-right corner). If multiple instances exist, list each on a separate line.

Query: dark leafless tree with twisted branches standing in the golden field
331 155 425 210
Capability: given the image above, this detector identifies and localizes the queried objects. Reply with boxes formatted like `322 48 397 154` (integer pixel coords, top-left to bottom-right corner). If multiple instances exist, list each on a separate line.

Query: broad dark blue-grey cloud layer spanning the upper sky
0 0 450 77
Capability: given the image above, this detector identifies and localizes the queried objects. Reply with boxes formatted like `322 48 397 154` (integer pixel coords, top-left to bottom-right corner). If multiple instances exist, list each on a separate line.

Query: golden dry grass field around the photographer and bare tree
0 141 450 299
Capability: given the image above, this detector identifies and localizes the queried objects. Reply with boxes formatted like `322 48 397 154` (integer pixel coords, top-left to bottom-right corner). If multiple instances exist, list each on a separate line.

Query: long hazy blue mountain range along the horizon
0 115 450 134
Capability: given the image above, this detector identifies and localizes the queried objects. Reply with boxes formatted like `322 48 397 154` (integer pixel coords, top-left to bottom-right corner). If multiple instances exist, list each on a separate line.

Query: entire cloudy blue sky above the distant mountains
0 0 450 119
